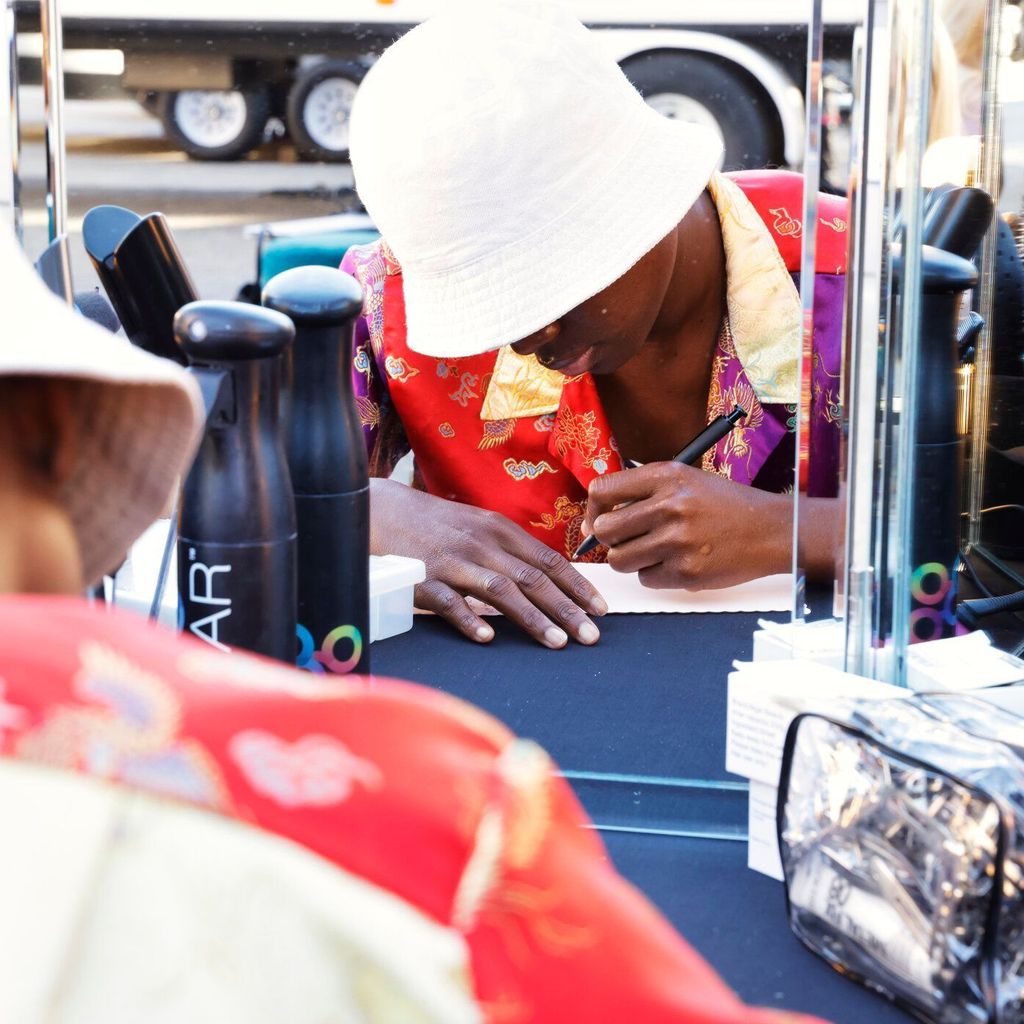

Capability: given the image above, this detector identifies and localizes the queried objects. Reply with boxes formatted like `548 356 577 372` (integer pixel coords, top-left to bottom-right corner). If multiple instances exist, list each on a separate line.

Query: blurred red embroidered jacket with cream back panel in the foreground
0 597 823 1024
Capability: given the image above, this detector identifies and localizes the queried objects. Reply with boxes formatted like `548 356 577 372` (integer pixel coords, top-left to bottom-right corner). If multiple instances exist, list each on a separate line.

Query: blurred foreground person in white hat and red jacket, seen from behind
0 230 814 1024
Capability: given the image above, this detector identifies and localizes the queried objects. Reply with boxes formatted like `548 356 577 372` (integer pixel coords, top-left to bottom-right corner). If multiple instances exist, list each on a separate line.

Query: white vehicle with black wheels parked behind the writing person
14 0 861 168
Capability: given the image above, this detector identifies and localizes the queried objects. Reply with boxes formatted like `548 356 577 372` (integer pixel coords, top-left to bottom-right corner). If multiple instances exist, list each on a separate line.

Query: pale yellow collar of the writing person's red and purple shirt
480 174 801 420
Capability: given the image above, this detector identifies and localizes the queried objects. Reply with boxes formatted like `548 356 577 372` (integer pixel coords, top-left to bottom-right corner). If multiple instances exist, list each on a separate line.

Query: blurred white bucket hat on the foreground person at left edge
0 225 204 584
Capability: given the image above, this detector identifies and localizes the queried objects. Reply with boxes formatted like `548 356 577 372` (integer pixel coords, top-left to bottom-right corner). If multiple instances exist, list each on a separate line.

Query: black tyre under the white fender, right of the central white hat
623 50 781 171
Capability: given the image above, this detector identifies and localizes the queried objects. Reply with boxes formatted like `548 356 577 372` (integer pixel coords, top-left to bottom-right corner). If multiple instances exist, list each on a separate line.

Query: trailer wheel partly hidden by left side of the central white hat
286 60 367 164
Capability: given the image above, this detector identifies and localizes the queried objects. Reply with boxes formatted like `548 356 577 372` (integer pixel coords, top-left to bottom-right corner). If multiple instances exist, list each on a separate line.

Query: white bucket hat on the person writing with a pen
350 0 722 357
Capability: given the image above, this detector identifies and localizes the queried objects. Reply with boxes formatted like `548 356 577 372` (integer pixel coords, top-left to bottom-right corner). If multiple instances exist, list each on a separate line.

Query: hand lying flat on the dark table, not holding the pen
370 479 608 648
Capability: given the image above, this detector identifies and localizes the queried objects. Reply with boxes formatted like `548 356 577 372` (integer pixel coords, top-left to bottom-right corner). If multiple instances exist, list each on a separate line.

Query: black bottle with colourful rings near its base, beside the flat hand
263 266 370 673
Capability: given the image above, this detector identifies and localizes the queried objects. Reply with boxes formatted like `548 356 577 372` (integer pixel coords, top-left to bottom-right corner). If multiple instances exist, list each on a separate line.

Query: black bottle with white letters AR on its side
174 302 296 663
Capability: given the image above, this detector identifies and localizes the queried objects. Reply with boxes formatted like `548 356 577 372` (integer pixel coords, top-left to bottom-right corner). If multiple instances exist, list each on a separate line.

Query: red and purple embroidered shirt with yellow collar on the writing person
342 171 846 560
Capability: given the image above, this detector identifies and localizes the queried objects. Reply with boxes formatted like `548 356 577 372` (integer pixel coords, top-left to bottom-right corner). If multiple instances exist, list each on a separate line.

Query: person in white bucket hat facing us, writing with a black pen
342 0 846 648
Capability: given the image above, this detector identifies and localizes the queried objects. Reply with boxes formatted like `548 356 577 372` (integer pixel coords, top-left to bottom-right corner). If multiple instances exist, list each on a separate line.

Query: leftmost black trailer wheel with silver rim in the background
157 88 270 160
